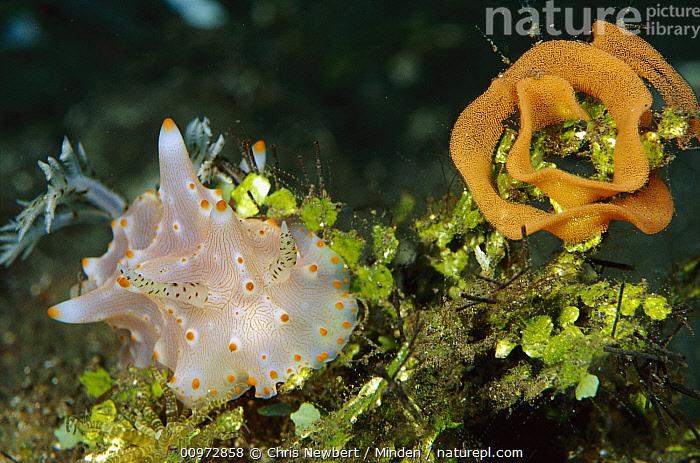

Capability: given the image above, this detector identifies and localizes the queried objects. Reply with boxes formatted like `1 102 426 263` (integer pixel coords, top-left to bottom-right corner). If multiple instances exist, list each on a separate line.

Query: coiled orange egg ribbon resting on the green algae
450 21 700 242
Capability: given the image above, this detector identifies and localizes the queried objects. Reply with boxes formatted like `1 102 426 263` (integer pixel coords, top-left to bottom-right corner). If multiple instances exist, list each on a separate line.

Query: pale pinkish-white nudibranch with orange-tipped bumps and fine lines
48 119 357 406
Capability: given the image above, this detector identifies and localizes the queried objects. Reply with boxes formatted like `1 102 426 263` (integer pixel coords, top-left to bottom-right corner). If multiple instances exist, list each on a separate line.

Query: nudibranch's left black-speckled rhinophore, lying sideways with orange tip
117 265 209 308
